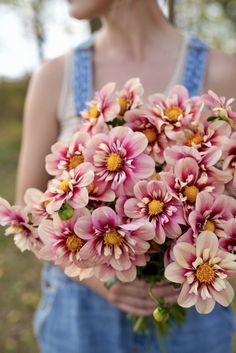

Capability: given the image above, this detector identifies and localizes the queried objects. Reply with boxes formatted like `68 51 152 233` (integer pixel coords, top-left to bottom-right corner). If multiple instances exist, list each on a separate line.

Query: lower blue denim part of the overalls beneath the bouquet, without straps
34 265 233 353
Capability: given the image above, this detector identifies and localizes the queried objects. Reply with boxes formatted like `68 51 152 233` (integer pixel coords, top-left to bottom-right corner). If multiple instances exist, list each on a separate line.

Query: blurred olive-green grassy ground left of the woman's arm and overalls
0 79 41 353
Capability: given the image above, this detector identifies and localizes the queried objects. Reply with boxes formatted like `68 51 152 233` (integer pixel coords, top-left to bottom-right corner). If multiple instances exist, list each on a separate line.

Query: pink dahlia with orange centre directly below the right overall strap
150 86 203 140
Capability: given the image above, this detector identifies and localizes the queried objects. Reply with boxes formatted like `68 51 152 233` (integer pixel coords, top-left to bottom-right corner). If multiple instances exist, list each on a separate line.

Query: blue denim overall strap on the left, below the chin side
72 37 94 115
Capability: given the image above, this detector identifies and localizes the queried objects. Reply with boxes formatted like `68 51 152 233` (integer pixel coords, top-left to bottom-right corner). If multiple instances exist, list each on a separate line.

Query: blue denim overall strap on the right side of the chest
182 37 208 96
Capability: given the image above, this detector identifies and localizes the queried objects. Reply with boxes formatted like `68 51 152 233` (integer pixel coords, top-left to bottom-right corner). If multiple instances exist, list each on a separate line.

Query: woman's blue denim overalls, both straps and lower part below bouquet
34 38 234 353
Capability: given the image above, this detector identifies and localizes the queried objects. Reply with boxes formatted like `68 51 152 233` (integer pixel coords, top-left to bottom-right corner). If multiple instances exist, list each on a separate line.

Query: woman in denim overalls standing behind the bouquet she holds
17 0 236 353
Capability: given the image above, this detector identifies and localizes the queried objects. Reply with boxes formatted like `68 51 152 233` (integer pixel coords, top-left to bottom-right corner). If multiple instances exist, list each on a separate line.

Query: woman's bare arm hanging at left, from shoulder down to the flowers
16 57 64 204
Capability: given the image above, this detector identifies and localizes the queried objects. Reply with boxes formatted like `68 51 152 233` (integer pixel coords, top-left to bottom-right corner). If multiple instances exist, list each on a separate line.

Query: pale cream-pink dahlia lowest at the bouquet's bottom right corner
165 231 236 314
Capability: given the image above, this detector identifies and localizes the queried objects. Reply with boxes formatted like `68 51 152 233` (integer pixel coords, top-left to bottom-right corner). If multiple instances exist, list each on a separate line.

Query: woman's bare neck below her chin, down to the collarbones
96 0 179 62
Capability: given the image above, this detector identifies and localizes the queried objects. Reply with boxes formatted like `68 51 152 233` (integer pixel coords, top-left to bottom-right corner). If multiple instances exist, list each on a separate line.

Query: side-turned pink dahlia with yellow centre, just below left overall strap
81 83 120 134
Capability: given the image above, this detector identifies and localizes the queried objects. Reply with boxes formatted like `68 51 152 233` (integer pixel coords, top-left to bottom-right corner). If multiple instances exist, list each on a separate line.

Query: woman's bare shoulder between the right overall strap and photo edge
204 48 236 98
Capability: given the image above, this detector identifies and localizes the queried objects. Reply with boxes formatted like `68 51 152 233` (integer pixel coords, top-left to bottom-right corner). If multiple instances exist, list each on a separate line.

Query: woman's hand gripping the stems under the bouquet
80 278 179 316
